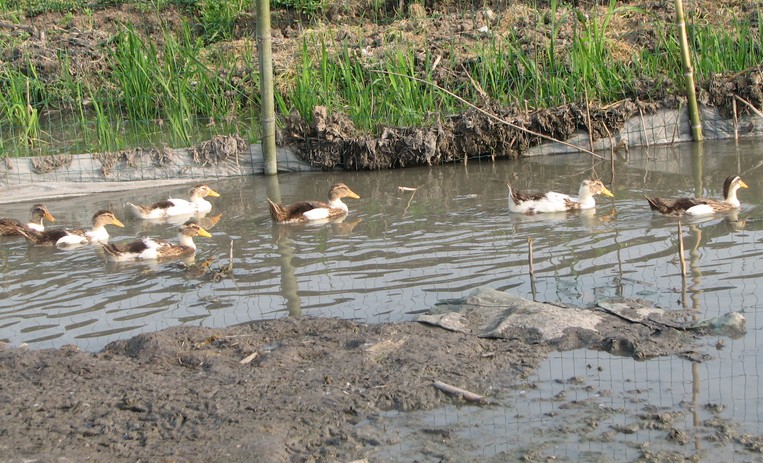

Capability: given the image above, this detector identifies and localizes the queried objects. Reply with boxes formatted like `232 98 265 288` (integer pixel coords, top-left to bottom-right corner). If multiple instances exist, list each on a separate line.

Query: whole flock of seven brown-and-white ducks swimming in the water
0 175 748 262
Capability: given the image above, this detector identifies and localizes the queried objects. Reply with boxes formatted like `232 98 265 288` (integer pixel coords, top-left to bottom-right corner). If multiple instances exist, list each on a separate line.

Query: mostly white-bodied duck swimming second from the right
507 180 615 214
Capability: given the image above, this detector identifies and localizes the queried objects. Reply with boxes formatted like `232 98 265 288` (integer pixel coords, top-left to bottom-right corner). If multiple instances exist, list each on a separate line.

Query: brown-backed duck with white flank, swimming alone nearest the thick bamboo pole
267 183 360 223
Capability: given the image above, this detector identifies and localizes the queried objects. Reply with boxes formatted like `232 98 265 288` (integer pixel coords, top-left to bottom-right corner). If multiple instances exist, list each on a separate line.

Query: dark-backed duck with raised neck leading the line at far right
644 175 749 216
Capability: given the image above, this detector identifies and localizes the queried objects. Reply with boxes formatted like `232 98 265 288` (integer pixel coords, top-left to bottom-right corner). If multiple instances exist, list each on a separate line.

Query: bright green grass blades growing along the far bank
0 0 763 158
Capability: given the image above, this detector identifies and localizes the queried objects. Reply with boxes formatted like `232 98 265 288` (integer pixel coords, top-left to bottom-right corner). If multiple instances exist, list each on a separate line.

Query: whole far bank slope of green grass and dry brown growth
0 0 763 155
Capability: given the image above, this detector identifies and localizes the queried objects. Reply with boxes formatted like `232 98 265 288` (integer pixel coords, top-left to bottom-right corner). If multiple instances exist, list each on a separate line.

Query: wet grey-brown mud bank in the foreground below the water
0 292 748 462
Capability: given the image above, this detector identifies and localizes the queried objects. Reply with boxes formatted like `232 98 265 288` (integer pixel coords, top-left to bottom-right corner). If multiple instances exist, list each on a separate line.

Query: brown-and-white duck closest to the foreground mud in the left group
101 219 212 262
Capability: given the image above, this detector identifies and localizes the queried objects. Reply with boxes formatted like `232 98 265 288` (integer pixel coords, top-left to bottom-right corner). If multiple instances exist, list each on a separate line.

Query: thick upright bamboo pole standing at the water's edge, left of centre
257 0 278 175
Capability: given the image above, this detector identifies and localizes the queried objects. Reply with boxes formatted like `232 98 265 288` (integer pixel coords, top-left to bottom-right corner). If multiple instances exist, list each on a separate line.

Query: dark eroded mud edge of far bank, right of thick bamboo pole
281 62 763 170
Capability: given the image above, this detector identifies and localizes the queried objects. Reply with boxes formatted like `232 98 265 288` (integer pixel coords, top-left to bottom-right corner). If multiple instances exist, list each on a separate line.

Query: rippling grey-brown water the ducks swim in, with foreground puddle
0 141 763 459
